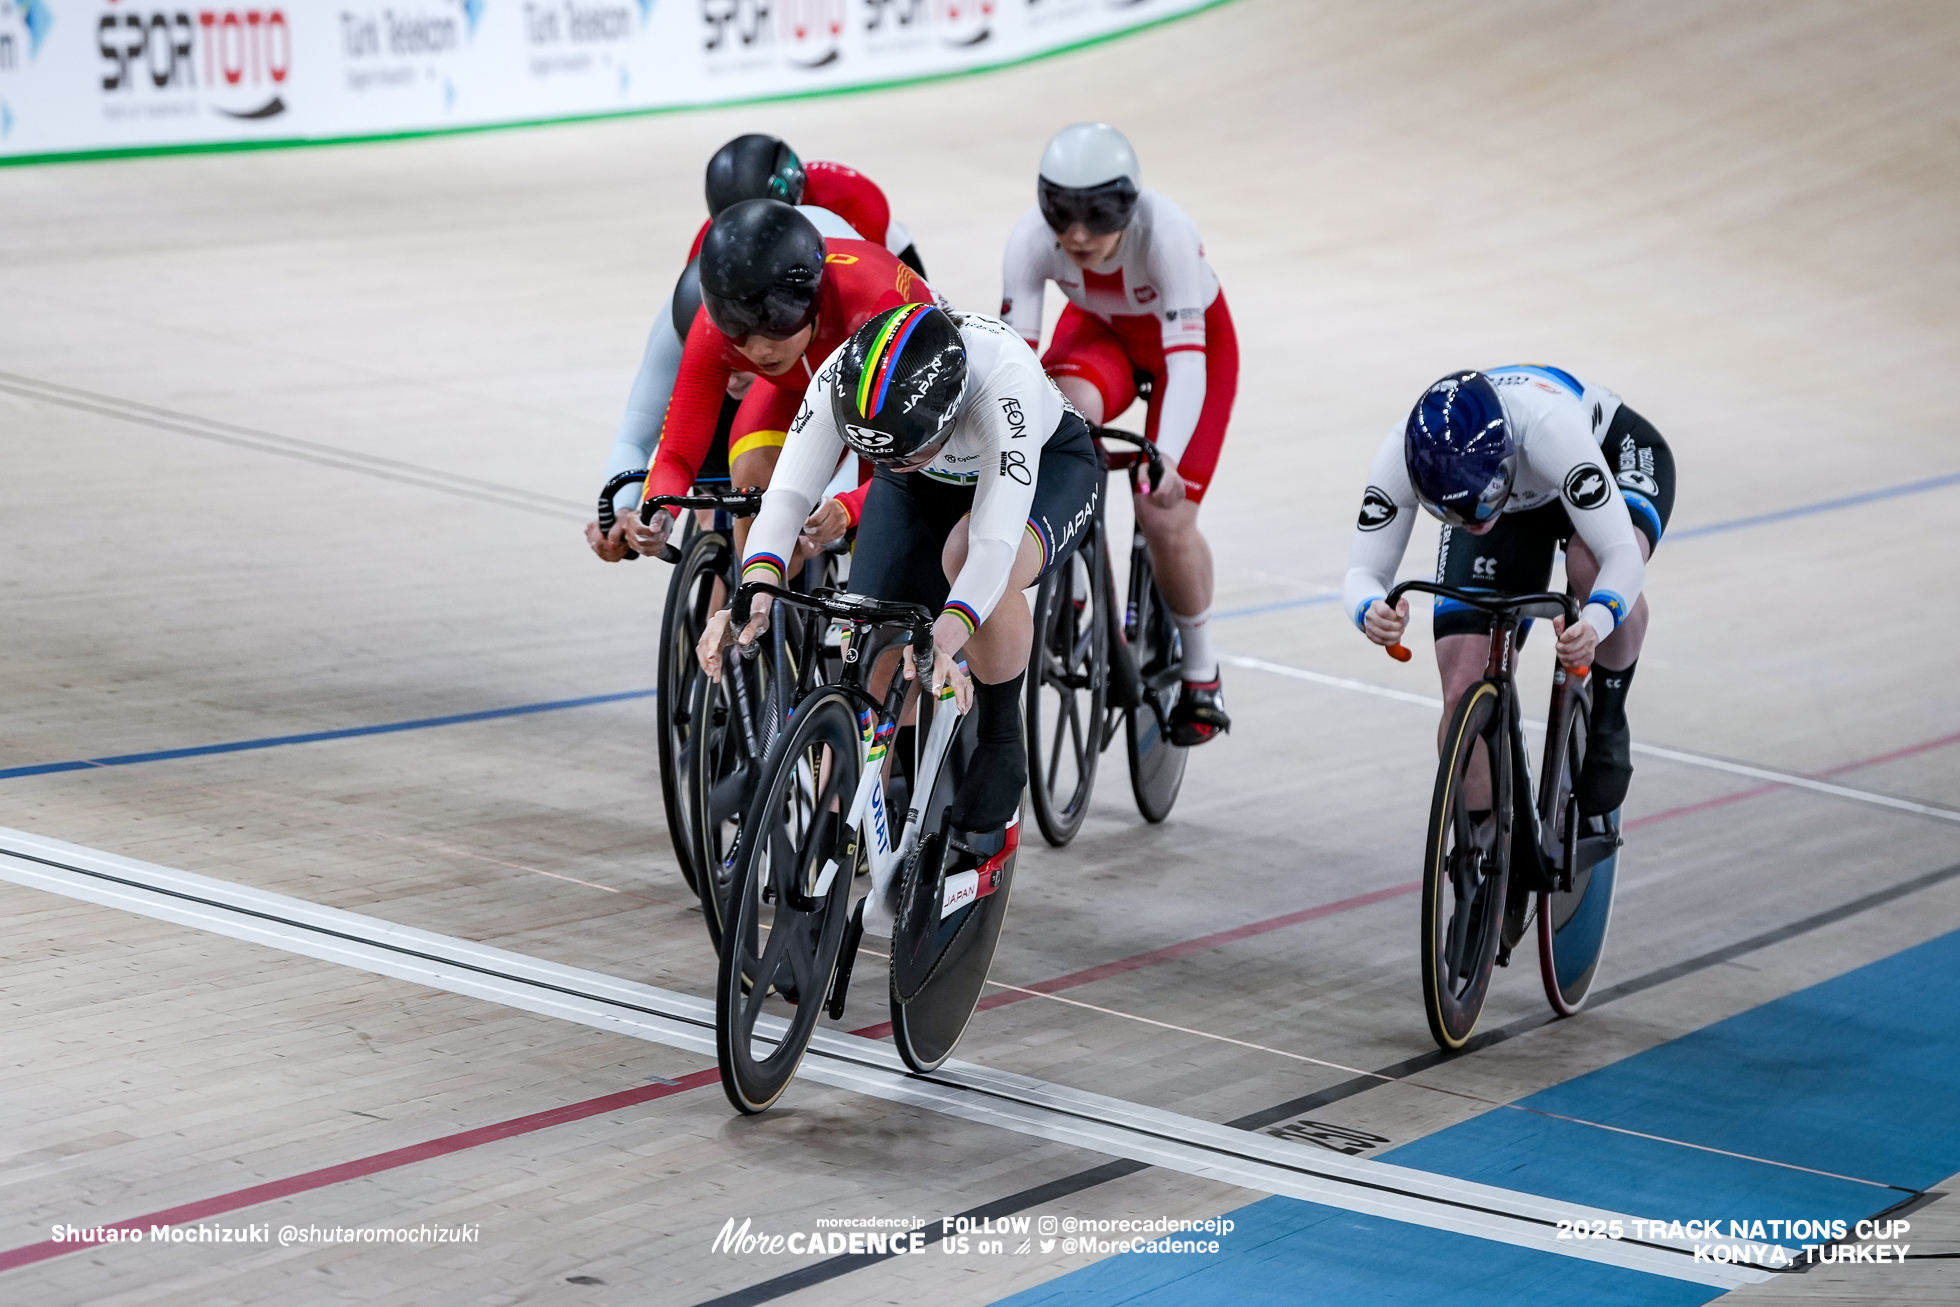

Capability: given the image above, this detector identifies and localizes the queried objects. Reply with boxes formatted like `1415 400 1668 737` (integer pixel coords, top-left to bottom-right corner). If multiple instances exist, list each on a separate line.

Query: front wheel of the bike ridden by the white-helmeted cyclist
1027 529 1109 848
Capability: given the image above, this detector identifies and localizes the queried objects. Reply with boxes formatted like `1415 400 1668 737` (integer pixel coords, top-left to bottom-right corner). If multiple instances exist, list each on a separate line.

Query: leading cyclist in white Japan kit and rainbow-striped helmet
700 304 1103 862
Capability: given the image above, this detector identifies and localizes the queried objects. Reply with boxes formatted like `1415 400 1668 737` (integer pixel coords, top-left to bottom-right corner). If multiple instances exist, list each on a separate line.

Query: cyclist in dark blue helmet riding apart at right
1343 364 1674 815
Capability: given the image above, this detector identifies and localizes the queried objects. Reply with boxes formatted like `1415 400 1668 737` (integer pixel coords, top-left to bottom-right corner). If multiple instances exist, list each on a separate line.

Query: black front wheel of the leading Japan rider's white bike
715 690 860 1113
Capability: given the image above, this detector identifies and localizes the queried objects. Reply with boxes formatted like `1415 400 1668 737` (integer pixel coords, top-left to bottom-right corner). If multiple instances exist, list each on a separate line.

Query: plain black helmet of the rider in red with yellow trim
700 200 823 343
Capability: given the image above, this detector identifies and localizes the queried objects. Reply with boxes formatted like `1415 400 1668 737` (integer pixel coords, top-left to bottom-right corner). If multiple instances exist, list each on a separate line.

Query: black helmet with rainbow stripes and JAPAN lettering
831 304 966 466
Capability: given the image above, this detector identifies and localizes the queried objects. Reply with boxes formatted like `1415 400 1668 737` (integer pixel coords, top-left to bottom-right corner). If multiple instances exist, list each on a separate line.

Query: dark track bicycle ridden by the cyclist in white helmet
1027 427 1190 847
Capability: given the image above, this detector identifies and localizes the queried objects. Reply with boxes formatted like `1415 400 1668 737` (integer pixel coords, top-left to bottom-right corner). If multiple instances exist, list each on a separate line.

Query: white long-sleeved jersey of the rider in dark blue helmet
1343 364 1646 639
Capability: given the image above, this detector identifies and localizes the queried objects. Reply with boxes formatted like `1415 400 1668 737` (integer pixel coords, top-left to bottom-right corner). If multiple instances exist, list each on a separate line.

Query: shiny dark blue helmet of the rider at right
1401 372 1517 527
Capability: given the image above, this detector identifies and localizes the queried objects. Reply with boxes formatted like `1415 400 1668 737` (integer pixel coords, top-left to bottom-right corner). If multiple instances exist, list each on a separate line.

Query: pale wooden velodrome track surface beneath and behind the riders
0 0 1960 1307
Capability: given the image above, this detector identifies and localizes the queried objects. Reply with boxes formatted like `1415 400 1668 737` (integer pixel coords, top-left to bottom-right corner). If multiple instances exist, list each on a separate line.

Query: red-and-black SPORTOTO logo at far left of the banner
96 0 294 120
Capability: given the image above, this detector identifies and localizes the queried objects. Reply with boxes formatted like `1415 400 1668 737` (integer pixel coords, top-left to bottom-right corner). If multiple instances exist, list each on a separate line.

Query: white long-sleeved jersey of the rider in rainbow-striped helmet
743 314 1072 627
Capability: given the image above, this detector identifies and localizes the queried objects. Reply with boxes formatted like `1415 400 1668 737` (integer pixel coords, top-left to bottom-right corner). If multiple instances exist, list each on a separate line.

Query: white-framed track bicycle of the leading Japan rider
715 582 1019 1113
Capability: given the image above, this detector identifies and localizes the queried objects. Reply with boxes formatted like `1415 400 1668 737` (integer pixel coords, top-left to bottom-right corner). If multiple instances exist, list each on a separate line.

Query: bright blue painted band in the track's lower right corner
1004 931 1960 1307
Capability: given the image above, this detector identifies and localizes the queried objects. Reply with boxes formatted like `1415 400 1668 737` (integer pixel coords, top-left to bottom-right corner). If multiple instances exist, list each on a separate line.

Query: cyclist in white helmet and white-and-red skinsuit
1000 123 1239 747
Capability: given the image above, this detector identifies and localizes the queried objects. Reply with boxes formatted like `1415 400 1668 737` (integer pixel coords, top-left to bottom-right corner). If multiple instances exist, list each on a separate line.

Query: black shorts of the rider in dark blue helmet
1435 404 1674 639
